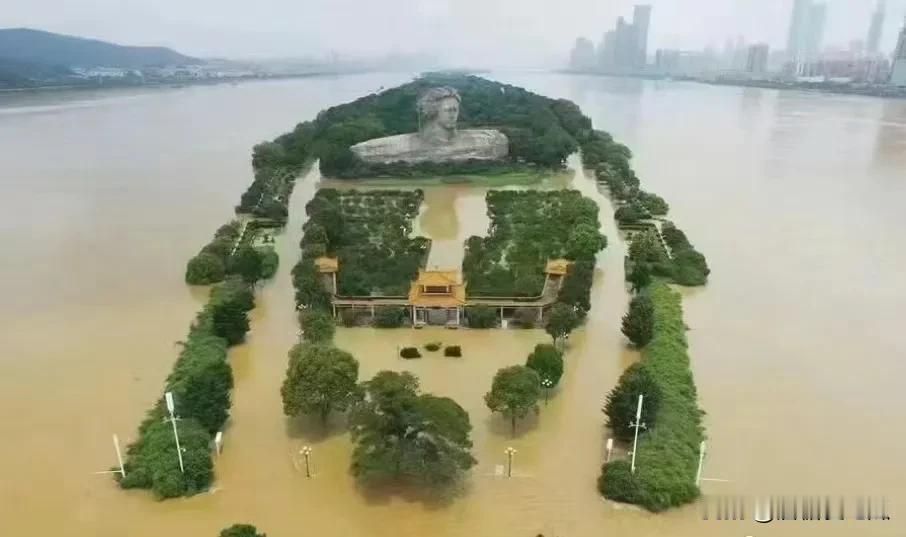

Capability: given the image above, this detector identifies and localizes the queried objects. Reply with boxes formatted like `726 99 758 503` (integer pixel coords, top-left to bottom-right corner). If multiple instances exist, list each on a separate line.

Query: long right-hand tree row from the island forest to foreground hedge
577 102 710 511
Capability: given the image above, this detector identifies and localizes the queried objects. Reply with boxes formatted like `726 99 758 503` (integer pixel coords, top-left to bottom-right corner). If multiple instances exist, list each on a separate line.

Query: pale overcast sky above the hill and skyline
0 0 906 65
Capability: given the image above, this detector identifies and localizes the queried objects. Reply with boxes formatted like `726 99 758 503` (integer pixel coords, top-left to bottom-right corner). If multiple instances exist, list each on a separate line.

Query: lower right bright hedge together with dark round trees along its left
598 281 704 511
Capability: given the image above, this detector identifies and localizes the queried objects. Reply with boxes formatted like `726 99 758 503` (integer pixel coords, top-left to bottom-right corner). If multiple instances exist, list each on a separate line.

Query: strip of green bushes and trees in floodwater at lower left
120 278 254 498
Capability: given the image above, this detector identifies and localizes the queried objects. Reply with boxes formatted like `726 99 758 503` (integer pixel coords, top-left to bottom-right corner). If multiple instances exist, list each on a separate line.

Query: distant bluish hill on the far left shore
0 28 204 69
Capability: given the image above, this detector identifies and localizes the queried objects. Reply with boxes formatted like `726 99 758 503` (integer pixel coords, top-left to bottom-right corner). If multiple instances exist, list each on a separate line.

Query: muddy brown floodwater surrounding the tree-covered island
0 73 906 537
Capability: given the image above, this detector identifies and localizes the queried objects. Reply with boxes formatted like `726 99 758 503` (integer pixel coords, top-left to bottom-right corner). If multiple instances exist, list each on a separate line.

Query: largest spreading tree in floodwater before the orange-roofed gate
350 371 476 485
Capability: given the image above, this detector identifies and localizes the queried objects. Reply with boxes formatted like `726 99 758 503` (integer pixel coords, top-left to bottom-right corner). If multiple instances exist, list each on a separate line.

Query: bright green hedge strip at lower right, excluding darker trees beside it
598 281 705 511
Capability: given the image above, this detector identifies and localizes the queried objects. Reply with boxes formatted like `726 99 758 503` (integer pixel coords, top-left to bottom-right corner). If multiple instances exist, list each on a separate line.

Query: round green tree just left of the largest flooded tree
280 344 359 424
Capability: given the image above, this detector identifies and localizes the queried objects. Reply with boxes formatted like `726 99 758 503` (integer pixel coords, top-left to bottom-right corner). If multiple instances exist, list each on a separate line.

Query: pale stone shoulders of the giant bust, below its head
350 129 509 164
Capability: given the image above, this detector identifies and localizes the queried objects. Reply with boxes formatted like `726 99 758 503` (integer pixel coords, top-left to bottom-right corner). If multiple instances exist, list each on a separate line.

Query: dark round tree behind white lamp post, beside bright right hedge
604 363 661 441
